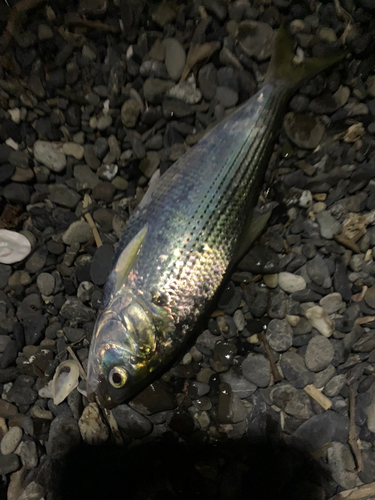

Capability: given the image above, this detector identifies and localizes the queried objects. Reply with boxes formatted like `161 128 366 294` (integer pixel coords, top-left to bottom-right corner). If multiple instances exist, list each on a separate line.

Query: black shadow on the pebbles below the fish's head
41 426 331 500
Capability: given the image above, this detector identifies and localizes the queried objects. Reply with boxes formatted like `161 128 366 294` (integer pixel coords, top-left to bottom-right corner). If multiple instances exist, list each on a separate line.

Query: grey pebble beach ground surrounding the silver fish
0 0 375 500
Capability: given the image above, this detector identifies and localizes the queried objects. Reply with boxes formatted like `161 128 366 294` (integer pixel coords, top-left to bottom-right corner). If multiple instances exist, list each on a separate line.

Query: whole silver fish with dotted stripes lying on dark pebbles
87 27 344 409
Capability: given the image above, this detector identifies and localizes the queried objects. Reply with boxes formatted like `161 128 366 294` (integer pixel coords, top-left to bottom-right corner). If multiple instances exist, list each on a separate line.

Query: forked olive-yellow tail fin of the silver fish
265 25 347 91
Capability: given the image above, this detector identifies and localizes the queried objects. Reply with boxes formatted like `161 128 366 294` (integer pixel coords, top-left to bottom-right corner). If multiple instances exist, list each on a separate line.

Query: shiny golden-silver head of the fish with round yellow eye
86 296 155 409
